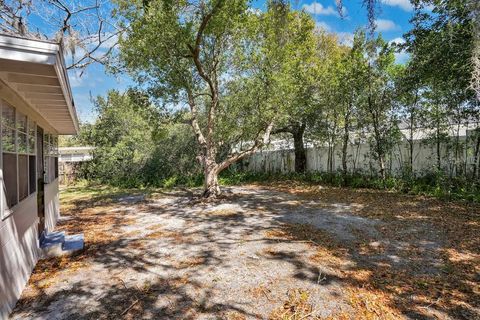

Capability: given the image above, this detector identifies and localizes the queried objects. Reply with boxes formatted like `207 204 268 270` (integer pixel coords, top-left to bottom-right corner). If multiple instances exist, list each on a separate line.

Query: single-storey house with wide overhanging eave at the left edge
0 35 83 319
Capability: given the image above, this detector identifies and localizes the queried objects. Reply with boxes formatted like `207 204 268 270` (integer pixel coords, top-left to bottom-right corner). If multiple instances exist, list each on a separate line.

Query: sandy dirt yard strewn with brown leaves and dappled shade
11 184 480 320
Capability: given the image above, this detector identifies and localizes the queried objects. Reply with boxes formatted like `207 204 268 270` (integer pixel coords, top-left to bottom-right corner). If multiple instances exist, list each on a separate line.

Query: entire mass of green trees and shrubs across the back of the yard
72 0 480 199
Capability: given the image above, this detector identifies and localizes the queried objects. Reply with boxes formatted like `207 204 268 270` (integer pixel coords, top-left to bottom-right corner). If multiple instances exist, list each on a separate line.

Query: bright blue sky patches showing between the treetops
70 0 413 121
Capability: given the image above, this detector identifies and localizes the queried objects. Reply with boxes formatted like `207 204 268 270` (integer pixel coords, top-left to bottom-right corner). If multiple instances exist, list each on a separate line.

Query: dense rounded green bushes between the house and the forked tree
80 91 198 187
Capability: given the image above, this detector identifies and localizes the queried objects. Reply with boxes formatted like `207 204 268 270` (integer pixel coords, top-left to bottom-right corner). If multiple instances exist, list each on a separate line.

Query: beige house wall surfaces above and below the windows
0 80 59 320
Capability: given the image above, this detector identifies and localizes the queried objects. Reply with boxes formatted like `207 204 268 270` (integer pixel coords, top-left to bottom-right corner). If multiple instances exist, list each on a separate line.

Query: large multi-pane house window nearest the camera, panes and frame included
0 100 36 215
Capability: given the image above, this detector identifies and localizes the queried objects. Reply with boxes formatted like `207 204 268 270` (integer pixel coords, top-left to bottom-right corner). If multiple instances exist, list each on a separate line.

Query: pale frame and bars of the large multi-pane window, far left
0 98 38 221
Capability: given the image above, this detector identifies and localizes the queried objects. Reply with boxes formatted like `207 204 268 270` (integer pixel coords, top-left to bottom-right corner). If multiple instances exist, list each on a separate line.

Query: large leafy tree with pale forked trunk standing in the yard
118 0 314 197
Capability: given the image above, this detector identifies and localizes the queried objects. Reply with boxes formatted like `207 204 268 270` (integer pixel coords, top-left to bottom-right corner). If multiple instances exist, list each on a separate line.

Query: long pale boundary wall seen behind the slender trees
243 137 480 175
